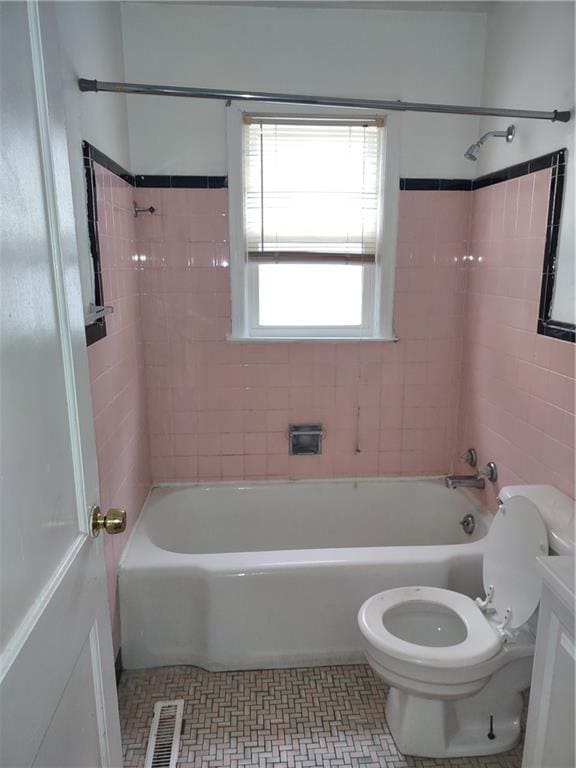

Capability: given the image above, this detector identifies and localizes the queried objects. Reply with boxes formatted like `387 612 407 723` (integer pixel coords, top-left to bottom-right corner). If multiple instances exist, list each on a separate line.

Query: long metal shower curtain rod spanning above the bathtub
78 77 571 123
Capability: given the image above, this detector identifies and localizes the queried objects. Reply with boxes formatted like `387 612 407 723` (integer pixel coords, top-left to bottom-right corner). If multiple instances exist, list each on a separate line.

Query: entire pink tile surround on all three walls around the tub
83 166 574 648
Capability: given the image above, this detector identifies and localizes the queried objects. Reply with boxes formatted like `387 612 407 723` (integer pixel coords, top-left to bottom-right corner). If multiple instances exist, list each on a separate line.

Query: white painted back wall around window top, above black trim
121 3 486 177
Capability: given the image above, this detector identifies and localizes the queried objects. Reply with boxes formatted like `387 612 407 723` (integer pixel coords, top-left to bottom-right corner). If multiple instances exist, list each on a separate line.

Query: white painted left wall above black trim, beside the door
52 2 130 306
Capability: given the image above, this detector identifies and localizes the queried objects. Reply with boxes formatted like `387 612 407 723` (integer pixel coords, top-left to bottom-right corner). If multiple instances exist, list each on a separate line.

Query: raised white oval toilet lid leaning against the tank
482 496 548 629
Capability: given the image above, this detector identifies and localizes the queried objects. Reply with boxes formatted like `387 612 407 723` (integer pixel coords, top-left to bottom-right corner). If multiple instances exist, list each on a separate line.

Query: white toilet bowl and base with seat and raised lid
358 486 554 757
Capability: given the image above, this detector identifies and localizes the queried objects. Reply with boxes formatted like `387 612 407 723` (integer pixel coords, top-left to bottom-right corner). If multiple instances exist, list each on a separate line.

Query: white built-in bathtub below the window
119 478 487 670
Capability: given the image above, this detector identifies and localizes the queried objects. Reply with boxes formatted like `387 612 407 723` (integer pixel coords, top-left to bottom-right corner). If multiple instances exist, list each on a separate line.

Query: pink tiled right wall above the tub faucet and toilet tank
458 170 574 505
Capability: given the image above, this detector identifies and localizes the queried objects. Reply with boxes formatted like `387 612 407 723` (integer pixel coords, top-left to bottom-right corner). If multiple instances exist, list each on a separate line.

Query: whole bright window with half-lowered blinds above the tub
229 110 398 338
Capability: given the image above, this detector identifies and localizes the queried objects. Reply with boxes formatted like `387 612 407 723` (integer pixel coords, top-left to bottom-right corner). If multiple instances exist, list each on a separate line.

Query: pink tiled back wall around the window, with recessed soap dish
137 189 471 481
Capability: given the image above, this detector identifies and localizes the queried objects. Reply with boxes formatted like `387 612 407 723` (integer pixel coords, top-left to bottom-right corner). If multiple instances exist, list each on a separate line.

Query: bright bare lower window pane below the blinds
258 264 364 326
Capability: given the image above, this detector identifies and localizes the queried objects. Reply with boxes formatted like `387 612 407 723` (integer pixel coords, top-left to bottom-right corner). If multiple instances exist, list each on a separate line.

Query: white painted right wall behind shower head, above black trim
478 2 576 323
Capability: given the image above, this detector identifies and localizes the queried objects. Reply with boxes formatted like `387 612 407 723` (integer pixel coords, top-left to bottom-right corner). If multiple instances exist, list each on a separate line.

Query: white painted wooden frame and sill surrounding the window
226 102 400 341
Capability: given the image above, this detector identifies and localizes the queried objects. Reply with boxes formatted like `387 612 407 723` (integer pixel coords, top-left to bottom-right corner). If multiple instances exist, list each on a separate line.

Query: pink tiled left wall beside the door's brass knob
88 165 150 651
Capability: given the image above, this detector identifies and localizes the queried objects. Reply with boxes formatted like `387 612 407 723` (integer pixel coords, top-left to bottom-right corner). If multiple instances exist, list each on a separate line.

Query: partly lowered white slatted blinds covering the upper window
244 116 382 263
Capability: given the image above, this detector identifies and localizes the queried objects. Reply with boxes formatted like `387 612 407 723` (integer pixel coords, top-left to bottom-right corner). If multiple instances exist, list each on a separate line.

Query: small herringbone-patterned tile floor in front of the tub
120 665 521 768
